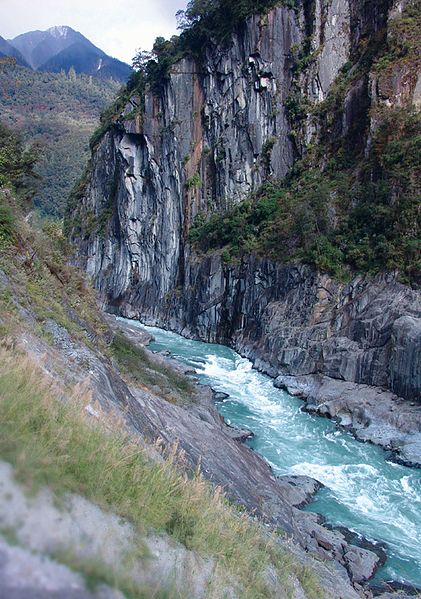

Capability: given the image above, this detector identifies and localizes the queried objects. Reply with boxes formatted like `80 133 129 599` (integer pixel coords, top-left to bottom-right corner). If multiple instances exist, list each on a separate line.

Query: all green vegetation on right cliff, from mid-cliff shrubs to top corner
190 3 421 284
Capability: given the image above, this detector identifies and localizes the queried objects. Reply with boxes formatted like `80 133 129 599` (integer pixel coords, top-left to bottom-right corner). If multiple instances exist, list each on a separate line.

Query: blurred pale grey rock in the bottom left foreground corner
0 461 230 599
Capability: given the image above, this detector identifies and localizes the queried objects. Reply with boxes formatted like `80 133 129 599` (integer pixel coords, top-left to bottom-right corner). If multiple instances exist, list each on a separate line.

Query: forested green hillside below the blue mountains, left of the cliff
0 65 120 218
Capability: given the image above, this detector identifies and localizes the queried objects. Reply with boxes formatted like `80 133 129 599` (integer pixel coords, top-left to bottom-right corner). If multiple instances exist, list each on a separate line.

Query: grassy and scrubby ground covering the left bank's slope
0 180 322 598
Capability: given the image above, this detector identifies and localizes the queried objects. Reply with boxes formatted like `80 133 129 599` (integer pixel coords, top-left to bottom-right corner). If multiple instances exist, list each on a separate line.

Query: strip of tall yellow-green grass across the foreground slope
0 348 322 598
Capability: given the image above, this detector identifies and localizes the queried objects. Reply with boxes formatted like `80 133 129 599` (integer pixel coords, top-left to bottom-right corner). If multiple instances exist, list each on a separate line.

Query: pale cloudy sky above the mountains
0 0 186 63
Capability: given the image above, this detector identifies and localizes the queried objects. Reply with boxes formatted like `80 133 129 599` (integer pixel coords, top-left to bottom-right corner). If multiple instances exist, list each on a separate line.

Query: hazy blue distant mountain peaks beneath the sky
4 25 132 82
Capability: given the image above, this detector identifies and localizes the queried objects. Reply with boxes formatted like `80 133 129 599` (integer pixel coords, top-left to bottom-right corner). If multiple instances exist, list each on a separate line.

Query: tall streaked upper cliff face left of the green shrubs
78 8 302 318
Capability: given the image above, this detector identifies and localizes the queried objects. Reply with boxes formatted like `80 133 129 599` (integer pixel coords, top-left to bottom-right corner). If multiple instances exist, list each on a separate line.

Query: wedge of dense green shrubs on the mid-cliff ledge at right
190 108 421 282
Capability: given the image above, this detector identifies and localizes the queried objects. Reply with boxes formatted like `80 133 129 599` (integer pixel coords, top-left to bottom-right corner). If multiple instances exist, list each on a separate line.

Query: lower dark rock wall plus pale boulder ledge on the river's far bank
113 255 421 465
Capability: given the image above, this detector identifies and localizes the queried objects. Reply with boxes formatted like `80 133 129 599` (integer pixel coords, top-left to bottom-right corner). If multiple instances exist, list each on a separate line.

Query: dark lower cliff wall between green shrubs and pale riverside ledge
119 254 421 406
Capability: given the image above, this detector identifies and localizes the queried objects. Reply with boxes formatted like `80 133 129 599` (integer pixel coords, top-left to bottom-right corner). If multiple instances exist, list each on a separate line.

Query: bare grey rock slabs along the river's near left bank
104 317 414 593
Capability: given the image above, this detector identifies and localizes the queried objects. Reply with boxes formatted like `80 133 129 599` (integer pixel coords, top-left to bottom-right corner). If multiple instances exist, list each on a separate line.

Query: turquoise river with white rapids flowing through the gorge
121 321 421 586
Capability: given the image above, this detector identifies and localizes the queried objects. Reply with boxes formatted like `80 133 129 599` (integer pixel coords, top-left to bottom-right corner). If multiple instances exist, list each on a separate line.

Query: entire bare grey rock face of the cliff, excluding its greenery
72 0 421 408
